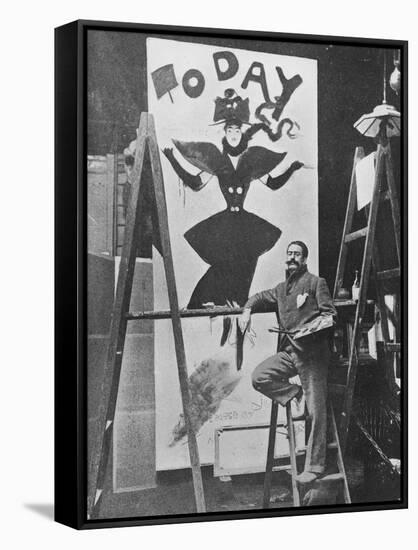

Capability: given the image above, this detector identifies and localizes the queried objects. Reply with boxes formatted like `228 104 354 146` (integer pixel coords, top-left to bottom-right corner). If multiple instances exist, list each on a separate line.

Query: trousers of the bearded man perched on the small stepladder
252 335 330 474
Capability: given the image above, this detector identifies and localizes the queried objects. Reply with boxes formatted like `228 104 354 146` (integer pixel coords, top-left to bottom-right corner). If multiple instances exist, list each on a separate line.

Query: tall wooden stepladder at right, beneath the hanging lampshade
333 137 401 454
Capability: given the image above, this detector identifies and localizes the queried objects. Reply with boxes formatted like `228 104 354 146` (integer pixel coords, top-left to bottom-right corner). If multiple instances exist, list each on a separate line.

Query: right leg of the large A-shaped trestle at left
147 114 206 512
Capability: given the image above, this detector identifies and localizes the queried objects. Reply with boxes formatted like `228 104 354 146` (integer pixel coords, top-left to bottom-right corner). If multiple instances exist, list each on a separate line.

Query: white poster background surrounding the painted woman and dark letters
147 38 318 470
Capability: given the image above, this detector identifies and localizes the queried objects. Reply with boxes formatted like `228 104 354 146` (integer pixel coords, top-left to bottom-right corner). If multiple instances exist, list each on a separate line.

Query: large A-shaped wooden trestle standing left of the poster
88 113 206 519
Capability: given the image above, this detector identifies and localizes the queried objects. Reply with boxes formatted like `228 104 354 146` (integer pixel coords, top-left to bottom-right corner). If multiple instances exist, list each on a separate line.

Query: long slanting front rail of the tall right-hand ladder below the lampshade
340 145 384 455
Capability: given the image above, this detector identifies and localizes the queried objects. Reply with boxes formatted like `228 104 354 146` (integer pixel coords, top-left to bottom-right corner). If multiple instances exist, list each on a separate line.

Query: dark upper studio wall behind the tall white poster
88 30 399 294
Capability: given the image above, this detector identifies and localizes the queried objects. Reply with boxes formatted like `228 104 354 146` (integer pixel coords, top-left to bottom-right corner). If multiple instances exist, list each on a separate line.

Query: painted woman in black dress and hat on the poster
164 89 303 309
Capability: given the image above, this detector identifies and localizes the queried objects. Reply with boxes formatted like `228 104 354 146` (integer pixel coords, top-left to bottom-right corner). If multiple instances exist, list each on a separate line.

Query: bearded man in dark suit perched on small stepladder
239 241 336 484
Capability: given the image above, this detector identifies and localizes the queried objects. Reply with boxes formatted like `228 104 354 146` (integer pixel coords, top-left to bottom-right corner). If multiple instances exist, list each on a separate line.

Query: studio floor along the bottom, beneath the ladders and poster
101 467 399 518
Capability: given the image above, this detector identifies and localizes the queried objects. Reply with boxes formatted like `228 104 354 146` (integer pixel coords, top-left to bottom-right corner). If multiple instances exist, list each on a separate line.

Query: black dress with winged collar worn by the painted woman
172 140 286 309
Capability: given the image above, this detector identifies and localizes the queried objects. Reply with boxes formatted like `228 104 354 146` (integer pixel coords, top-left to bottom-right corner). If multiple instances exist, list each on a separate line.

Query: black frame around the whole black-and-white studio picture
55 20 408 529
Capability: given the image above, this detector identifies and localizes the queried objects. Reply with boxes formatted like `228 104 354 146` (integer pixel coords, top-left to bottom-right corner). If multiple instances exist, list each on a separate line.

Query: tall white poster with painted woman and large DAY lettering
147 38 318 470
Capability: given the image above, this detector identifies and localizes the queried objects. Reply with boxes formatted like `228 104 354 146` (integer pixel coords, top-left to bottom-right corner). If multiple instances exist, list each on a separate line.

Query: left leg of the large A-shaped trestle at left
88 113 147 519
